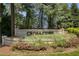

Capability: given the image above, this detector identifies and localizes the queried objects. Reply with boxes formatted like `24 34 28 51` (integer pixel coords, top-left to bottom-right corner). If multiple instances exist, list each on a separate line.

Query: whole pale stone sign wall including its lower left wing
2 29 65 45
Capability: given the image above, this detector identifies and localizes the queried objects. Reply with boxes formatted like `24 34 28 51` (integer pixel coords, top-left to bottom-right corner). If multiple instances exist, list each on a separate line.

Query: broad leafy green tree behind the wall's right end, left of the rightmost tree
55 4 72 28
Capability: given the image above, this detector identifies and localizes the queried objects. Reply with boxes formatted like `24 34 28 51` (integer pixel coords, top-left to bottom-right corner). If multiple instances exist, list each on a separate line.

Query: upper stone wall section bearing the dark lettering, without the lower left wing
15 28 60 37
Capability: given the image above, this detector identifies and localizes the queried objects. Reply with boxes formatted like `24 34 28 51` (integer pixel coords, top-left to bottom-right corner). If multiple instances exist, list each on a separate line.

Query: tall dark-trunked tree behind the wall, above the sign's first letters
23 4 34 29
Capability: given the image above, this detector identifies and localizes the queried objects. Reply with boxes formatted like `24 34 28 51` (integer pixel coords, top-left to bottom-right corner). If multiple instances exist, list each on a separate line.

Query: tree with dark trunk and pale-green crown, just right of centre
44 4 56 29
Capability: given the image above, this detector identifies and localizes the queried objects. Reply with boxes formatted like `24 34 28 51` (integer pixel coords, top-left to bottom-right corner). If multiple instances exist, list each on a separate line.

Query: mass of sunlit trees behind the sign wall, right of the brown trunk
15 3 79 29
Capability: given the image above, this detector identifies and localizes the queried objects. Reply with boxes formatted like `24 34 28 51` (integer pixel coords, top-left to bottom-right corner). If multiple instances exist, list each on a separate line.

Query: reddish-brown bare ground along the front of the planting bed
0 46 75 56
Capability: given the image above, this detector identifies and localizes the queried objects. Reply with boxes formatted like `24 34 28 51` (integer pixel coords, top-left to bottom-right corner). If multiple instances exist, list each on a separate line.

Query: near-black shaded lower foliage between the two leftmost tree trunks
1 15 11 36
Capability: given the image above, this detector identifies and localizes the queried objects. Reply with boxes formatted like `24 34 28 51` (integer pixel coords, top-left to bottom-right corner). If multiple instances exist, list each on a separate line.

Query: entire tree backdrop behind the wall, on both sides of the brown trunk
1 3 79 34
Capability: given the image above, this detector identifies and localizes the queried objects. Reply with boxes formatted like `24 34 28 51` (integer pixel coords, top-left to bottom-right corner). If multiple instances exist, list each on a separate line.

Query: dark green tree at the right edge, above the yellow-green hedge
71 3 79 27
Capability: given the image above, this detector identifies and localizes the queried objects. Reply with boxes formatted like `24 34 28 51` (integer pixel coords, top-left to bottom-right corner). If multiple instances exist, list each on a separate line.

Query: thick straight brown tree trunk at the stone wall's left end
10 3 15 37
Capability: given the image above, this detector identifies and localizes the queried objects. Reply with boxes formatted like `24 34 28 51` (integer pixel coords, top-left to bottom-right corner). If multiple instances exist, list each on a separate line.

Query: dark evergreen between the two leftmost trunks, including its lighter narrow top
1 4 11 36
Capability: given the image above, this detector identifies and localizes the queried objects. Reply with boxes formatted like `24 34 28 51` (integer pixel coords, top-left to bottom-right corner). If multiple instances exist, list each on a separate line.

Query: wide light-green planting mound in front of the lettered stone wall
25 34 76 48
